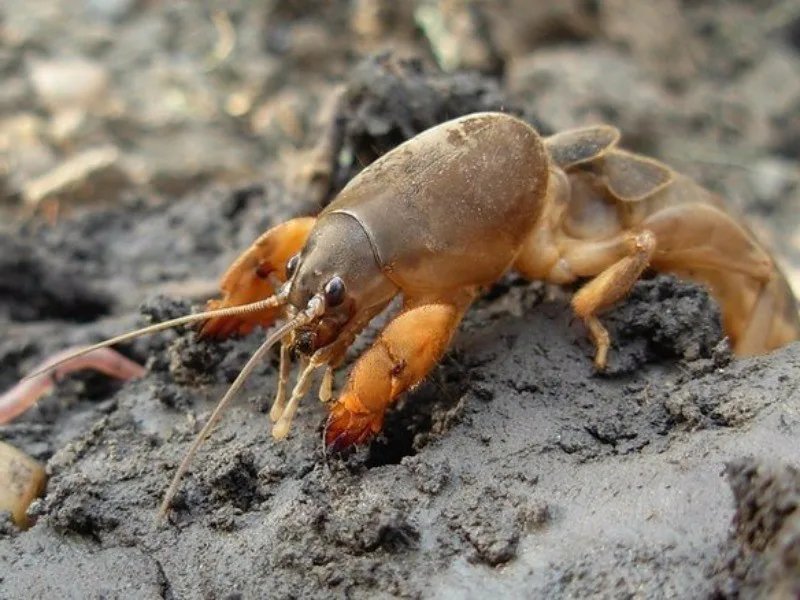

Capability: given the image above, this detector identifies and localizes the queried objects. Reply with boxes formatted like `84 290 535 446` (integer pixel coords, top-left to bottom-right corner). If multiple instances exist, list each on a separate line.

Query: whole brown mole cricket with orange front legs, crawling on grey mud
26 113 800 508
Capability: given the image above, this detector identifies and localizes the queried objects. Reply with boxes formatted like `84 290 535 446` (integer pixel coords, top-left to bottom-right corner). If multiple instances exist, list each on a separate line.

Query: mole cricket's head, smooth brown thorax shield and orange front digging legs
203 113 549 448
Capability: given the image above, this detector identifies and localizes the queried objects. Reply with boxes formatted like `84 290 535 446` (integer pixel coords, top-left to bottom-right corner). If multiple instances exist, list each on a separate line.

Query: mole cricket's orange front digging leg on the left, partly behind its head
200 217 316 339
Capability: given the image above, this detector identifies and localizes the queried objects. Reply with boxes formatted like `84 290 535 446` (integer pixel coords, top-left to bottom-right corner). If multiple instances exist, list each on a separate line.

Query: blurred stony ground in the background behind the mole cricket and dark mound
0 0 800 290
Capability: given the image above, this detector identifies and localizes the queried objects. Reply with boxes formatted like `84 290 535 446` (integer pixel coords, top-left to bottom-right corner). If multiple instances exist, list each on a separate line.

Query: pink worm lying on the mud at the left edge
0 348 145 425
